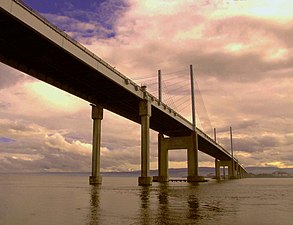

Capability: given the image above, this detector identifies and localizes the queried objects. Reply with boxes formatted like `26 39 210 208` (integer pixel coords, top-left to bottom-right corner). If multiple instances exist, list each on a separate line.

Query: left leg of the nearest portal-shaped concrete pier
153 133 168 182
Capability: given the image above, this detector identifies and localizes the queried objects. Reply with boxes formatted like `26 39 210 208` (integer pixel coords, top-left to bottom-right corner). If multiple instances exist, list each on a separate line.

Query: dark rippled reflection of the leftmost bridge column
87 185 101 225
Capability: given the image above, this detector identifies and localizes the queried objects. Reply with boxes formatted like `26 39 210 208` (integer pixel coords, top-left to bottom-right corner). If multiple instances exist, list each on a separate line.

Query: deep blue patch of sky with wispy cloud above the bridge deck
25 0 128 41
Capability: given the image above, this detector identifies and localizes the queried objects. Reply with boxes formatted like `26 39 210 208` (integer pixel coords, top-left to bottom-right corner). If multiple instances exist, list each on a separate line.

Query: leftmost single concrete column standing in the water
89 104 103 185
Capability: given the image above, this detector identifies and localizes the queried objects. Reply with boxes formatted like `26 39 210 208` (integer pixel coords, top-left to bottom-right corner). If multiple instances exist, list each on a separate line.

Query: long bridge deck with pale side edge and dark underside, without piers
0 0 248 185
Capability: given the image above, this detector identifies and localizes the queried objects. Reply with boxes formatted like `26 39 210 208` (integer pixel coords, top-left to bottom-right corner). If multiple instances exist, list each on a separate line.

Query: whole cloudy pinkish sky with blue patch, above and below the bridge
0 0 293 172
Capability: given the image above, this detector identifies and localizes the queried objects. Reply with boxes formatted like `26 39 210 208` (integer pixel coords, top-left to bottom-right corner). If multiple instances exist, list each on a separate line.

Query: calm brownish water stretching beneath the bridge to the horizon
0 174 293 225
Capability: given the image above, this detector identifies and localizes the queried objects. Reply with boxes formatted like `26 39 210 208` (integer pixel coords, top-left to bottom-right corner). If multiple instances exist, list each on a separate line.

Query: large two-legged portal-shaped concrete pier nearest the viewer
154 132 204 183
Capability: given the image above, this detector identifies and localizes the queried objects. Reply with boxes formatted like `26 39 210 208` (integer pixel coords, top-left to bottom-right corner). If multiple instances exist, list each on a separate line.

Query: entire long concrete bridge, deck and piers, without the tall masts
0 0 247 185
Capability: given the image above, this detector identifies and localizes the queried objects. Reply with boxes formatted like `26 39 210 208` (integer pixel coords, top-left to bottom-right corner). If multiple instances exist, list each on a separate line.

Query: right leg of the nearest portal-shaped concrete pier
187 132 204 183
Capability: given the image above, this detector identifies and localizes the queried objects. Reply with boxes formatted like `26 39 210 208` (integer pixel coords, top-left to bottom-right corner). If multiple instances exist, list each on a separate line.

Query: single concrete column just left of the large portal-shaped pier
138 100 152 186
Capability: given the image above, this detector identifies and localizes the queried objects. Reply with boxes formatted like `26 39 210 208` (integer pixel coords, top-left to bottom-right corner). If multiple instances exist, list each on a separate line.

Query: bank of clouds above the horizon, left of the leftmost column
0 120 91 172
